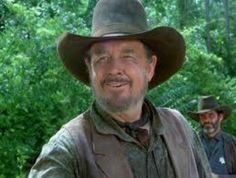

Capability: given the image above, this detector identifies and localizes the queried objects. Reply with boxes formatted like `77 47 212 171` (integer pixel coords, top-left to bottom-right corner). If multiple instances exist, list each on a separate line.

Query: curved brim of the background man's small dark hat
188 105 232 122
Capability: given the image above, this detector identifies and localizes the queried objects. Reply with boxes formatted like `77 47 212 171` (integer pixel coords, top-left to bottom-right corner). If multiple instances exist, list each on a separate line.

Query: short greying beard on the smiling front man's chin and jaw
91 73 148 113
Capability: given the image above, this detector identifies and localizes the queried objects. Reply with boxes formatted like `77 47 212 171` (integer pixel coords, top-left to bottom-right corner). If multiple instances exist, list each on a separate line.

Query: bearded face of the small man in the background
199 110 223 137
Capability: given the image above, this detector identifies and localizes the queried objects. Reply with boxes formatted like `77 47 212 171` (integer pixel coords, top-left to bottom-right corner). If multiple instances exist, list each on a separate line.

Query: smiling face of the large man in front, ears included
86 40 157 112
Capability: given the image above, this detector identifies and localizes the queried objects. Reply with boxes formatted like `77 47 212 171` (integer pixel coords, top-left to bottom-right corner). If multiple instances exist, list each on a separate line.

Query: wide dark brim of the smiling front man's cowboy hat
58 27 185 89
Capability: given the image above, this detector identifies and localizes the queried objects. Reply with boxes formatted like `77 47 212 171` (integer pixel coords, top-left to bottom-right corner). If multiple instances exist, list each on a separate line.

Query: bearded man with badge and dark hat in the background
189 96 236 178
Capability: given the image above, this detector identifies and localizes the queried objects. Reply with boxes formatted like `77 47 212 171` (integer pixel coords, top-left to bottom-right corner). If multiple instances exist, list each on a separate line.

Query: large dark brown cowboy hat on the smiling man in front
58 0 185 88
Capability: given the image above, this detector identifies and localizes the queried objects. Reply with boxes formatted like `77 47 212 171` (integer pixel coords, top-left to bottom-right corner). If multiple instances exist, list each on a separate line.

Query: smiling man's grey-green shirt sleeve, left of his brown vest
29 114 89 177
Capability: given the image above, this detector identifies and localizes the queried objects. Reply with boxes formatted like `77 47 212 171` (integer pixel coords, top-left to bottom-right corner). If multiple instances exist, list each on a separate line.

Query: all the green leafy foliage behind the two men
0 0 236 178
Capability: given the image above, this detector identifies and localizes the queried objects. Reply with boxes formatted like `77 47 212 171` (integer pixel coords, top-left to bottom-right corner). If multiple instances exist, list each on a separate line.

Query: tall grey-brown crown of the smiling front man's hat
91 0 148 37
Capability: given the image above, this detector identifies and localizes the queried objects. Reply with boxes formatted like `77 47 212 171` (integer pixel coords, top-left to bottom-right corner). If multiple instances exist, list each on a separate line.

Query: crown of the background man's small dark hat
198 96 219 111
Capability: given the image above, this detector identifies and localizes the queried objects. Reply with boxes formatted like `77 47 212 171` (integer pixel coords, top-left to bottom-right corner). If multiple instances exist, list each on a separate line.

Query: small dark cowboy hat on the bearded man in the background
188 96 232 121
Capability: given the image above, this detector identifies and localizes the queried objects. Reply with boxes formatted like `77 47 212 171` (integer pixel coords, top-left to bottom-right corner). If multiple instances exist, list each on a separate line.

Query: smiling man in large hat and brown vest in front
29 0 211 178
